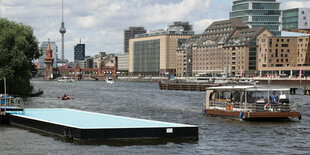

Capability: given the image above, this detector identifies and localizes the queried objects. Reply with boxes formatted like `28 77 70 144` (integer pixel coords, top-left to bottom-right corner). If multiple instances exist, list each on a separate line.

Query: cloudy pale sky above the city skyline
0 0 310 61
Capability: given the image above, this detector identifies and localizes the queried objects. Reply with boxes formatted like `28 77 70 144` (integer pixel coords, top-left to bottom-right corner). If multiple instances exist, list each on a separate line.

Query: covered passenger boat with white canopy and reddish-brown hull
203 86 301 120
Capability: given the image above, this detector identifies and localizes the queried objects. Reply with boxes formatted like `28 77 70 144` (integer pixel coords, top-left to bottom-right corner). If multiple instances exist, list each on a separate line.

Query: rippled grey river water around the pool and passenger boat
0 81 310 154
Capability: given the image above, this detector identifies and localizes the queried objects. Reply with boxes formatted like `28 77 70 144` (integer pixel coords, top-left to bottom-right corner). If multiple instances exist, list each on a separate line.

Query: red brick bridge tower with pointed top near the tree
44 42 54 80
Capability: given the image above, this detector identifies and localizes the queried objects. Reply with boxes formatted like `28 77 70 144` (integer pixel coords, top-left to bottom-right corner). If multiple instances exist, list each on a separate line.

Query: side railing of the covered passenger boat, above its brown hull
209 101 297 112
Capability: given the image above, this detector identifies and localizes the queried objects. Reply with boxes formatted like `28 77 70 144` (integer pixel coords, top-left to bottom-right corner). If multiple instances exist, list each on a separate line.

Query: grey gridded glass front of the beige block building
133 39 160 73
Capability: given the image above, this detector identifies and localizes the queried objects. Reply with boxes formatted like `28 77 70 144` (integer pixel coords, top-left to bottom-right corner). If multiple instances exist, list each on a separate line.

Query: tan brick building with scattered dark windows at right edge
257 34 310 76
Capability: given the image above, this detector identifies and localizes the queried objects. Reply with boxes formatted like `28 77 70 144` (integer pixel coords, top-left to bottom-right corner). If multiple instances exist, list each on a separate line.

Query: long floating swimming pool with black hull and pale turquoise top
4 108 198 142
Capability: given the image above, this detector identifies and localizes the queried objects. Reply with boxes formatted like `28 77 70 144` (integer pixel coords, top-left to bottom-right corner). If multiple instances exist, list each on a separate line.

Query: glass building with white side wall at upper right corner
282 8 310 34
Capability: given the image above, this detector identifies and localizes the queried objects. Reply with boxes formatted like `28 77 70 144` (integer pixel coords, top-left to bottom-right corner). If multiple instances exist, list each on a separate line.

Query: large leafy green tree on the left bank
0 18 42 96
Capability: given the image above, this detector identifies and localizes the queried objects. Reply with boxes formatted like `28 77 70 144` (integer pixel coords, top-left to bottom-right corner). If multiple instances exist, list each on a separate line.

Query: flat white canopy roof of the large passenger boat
207 86 290 91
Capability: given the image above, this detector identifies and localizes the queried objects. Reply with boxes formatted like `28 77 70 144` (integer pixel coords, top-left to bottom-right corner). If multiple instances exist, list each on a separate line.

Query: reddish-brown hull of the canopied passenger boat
206 109 300 120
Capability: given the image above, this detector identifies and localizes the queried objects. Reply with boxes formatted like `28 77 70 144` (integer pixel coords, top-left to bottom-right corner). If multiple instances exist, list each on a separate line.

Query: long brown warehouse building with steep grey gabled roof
177 19 272 76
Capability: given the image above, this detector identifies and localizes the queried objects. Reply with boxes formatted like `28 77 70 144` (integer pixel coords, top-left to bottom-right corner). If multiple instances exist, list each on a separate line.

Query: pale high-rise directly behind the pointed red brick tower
38 41 58 68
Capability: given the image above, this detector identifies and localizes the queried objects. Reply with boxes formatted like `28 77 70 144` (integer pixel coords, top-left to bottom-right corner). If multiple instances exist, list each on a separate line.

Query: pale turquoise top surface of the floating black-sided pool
10 109 195 129
